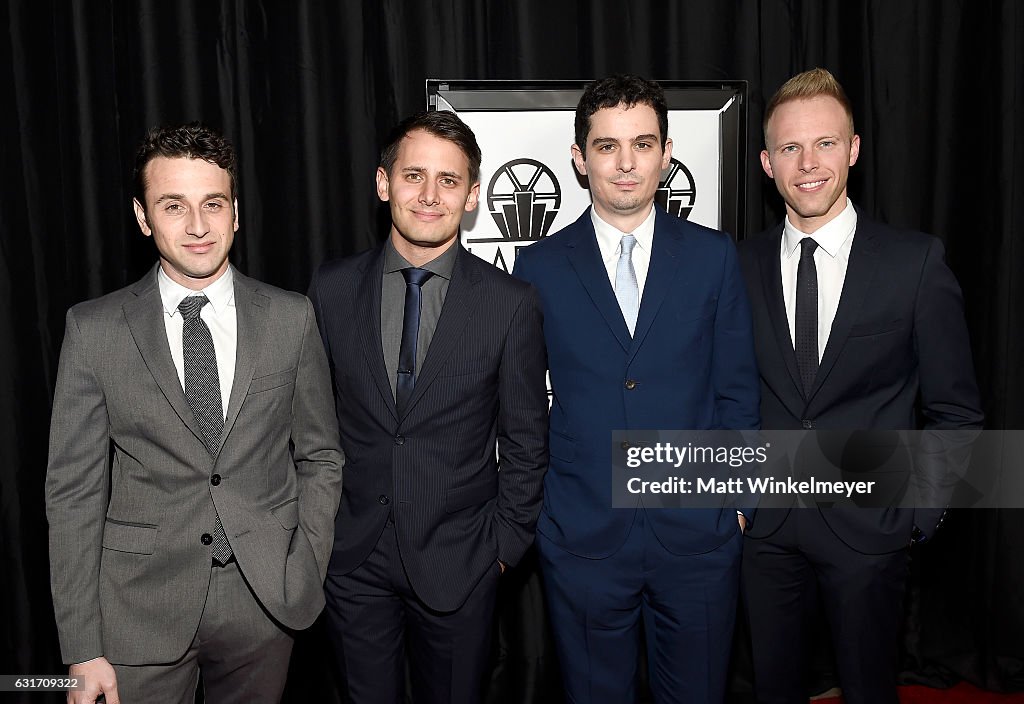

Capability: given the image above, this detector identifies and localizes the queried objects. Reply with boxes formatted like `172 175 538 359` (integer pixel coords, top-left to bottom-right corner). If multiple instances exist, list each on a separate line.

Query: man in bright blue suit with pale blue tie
514 76 759 704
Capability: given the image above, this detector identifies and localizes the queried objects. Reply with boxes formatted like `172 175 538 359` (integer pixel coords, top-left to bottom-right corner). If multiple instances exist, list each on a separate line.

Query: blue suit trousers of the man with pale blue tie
537 509 741 704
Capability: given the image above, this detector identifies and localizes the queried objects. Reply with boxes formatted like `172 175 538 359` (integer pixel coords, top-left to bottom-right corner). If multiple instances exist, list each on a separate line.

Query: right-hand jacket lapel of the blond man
807 220 880 401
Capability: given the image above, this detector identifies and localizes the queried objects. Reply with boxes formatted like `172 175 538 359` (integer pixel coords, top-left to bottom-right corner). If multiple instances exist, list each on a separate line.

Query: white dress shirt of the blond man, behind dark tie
779 199 857 362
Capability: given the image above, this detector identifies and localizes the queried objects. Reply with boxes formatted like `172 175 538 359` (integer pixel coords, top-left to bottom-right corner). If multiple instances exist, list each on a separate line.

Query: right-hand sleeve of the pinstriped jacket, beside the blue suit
494 287 548 565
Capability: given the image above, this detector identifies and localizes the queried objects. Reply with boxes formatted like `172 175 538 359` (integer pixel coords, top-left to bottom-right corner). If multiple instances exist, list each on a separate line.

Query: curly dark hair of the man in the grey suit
134 122 238 209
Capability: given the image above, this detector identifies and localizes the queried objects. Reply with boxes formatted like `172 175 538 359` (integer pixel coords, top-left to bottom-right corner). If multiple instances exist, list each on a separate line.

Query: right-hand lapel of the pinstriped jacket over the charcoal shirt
399 244 481 415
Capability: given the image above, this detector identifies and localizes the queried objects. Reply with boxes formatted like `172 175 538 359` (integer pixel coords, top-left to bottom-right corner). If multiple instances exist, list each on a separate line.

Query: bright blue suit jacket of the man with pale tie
514 209 759 558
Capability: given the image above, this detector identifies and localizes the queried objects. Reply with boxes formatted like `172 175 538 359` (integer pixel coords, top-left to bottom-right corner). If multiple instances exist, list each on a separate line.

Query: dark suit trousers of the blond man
741 508 910 704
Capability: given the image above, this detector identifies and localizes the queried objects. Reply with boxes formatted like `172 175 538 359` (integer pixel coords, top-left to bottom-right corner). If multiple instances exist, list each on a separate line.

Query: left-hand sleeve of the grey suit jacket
46 310 110 664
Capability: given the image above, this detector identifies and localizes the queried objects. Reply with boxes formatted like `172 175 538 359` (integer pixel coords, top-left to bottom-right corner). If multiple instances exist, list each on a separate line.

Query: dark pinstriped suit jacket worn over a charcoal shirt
309 247 548 611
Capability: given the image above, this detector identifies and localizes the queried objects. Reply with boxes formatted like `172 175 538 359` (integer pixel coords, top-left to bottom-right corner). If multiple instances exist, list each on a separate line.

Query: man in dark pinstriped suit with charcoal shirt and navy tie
310 112 548 704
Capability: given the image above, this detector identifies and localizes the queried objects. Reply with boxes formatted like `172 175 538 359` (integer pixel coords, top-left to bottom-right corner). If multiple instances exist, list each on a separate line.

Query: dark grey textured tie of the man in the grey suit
178 294 231 565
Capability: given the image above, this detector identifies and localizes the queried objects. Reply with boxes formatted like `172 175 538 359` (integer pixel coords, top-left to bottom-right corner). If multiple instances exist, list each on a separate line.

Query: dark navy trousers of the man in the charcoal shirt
326 518 501 704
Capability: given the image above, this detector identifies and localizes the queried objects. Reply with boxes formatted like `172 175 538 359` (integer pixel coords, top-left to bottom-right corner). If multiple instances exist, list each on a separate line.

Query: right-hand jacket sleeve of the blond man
913 237 984 535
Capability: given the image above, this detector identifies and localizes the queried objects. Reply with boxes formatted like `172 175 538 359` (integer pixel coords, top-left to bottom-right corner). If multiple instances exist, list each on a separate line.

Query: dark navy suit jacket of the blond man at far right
739 210 983 554
